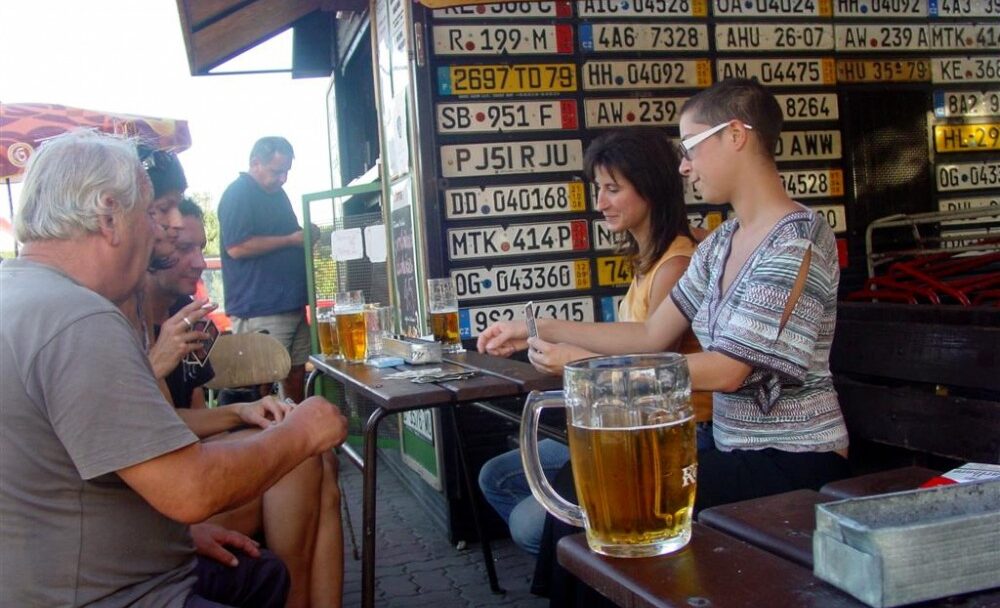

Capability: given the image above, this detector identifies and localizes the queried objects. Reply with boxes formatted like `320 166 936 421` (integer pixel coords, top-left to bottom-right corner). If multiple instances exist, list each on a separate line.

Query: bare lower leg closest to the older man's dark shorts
263 458 323 608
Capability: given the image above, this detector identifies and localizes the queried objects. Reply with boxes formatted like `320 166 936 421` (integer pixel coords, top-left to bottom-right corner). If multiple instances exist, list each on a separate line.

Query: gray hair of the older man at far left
14 131 151 243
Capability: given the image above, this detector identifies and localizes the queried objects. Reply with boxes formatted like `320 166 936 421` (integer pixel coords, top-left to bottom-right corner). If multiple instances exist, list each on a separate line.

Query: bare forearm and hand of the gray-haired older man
118 397 347 523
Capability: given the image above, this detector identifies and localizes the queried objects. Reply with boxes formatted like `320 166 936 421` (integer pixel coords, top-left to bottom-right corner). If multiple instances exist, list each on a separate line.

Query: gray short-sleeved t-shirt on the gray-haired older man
0 260 203 607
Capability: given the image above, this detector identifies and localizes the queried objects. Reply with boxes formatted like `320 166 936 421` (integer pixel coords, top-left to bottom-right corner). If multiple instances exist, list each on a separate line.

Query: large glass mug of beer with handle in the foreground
521 353 698 557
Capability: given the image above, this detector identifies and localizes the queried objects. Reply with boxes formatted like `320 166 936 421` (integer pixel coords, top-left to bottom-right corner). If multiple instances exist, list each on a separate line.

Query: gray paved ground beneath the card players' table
340 457 548 608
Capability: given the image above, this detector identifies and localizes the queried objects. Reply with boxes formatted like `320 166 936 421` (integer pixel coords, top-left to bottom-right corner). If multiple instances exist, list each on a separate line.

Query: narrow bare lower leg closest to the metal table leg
312 452 344 608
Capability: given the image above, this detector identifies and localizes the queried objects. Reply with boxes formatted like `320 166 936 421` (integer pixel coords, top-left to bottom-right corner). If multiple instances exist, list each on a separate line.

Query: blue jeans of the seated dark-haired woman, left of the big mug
479 439 569 555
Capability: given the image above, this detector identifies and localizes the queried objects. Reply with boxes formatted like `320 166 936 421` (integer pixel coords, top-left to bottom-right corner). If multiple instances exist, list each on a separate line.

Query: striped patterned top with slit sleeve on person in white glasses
670 208 847 452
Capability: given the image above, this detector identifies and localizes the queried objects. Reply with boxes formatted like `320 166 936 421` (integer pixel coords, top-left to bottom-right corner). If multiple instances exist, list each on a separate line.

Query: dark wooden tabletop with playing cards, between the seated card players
309 352 562 411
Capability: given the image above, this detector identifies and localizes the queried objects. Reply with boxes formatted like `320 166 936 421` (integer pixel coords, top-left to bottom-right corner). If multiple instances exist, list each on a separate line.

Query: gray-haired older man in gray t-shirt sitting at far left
0 133 346 608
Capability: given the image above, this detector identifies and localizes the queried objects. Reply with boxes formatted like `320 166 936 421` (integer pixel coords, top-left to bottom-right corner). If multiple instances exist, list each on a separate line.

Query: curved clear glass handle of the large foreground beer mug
521 391 583 528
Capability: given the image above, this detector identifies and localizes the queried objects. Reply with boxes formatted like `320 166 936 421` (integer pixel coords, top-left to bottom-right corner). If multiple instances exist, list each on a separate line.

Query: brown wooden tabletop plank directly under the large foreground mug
558 523 864 608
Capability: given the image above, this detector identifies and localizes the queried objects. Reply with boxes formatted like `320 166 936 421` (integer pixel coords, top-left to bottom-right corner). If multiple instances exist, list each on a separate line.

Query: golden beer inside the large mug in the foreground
569 416 698 555
